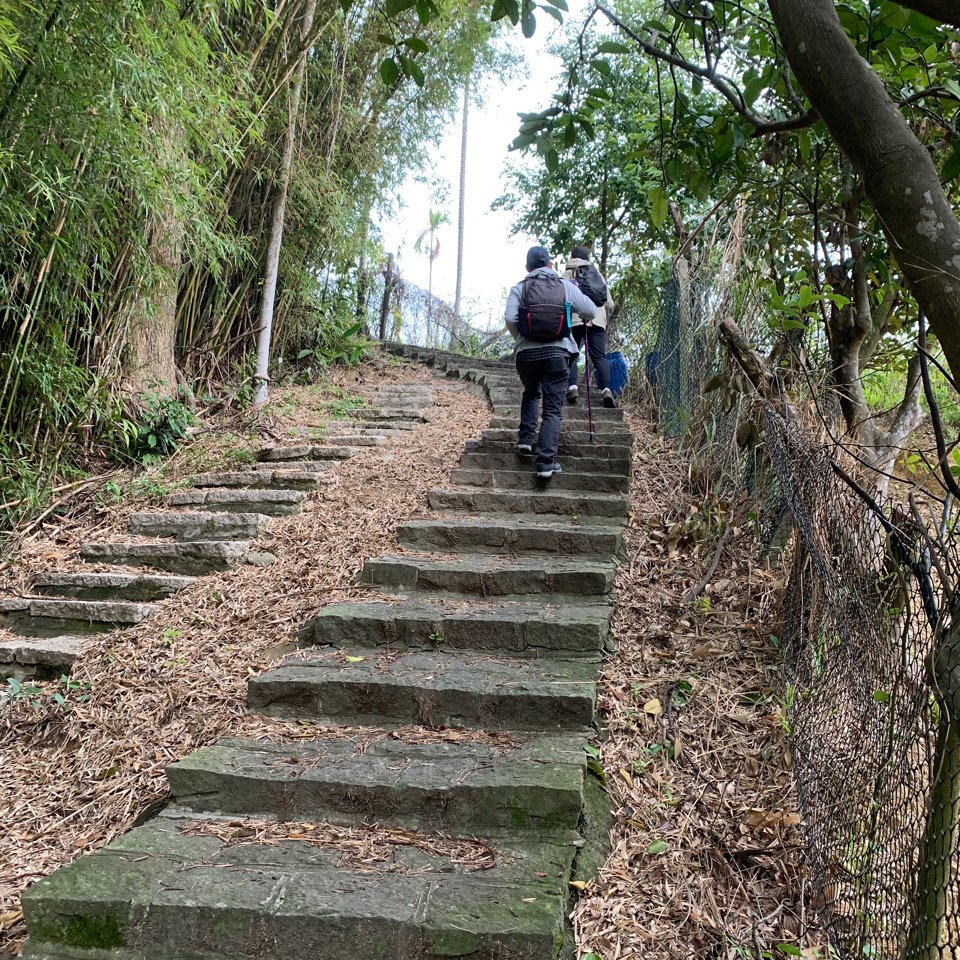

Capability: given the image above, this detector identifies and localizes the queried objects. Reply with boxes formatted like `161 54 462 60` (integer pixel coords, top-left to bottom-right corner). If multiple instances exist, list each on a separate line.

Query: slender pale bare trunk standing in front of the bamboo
254 0 317 407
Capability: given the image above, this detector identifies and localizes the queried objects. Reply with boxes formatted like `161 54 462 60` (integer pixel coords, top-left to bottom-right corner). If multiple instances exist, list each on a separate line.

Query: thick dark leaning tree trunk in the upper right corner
769 0 960 390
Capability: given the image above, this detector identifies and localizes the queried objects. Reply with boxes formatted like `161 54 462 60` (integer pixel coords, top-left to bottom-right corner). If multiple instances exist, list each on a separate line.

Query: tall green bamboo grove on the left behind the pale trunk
0 0 494 502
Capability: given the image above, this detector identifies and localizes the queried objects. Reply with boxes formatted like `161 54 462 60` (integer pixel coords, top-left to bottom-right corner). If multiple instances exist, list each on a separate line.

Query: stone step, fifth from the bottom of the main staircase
361 551 614 597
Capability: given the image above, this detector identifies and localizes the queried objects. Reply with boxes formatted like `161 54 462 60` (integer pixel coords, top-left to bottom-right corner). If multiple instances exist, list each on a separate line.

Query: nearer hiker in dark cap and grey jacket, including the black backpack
504 245 597 480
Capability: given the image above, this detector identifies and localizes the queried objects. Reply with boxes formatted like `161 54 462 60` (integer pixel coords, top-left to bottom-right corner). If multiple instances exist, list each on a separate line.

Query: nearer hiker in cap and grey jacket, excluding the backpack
503 246 597 480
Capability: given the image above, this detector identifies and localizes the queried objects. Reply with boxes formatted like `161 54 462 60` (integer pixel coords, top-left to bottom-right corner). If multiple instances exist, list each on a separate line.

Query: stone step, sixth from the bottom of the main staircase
397 517 623 557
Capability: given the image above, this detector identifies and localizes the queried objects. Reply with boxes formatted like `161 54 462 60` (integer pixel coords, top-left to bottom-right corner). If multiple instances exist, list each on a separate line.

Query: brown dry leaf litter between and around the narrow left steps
0 363 488 956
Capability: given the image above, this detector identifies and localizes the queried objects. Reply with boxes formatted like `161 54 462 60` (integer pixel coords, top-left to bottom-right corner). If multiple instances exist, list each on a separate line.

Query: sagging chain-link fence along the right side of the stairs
622 219 960 960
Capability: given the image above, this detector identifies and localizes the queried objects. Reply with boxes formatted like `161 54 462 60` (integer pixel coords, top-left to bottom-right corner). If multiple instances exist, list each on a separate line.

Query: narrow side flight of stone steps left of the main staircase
0 385 433 680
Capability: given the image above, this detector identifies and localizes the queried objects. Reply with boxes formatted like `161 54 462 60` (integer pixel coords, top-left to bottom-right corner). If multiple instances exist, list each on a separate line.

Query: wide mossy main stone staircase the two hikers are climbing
16 348 630 960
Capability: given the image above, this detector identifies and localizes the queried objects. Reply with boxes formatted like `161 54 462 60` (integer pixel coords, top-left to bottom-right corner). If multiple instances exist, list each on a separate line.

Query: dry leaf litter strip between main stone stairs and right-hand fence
574 410 812 960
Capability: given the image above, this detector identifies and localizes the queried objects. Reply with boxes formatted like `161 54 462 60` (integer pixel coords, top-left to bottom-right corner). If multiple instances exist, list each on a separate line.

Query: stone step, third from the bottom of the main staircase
247 647 597 733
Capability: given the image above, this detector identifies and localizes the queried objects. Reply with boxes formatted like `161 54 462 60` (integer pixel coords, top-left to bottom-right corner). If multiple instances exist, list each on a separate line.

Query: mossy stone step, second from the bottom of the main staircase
167 735 586 837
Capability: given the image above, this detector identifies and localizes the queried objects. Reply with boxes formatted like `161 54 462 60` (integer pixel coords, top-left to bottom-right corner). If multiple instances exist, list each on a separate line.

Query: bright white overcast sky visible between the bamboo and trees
381 0 587 328
